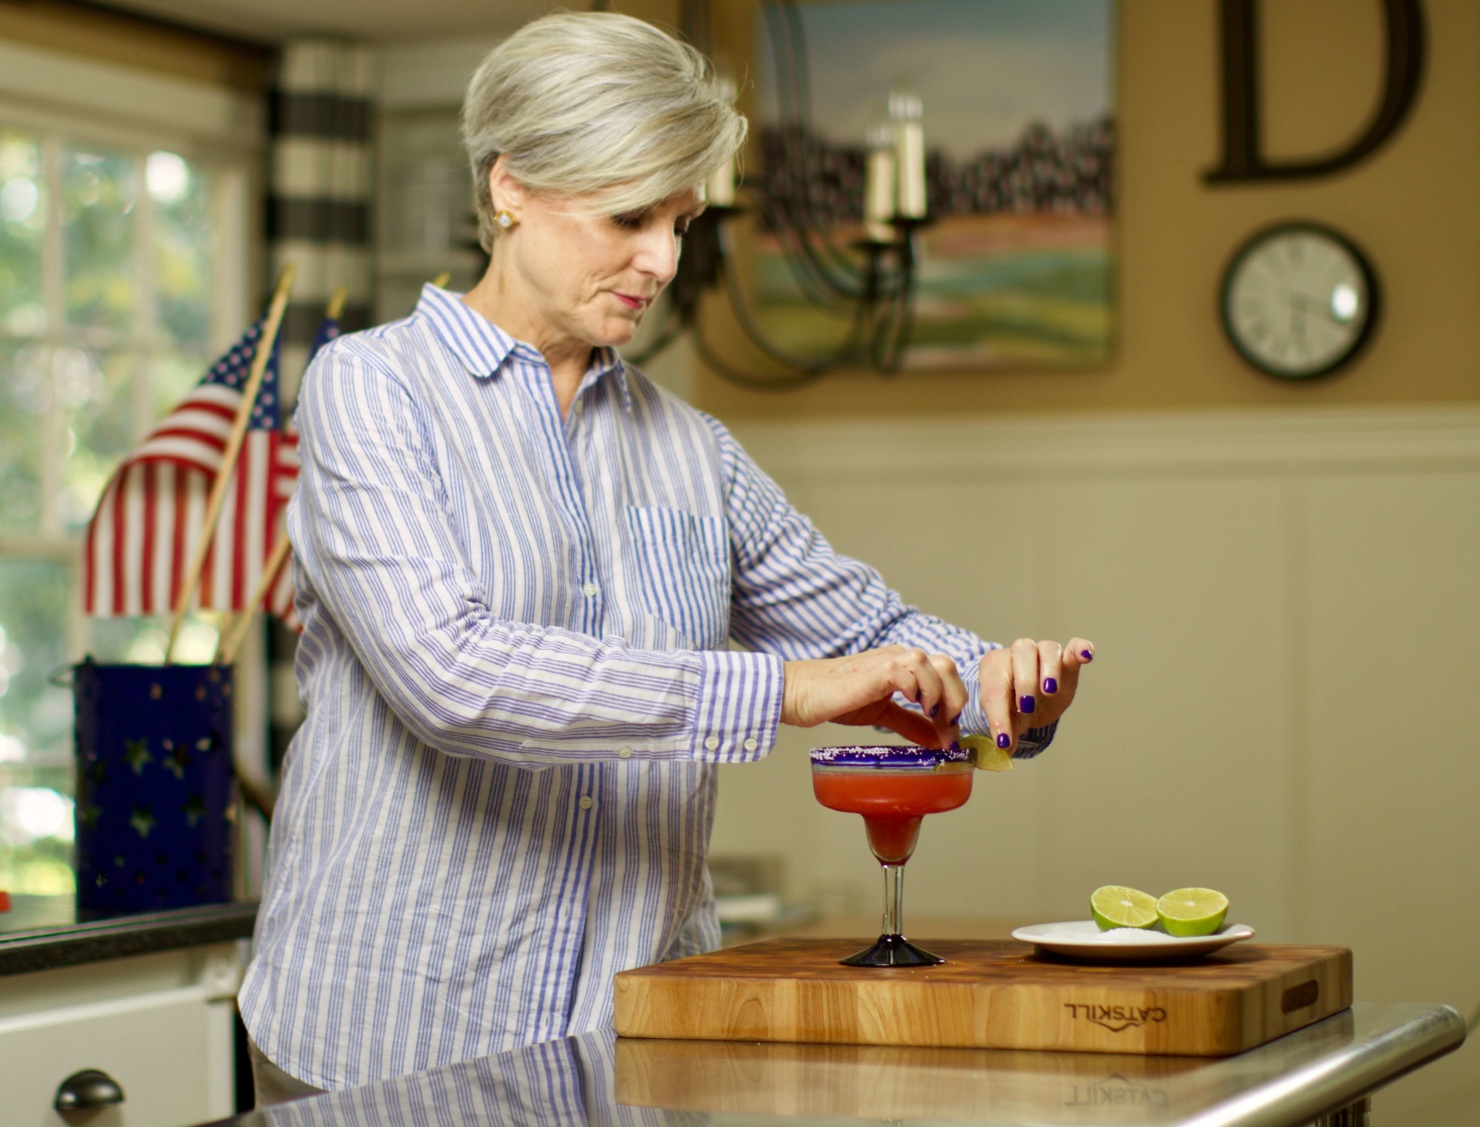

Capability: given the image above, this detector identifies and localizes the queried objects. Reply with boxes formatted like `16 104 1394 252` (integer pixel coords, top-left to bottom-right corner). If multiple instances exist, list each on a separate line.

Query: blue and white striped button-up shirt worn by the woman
241 287 1049 1088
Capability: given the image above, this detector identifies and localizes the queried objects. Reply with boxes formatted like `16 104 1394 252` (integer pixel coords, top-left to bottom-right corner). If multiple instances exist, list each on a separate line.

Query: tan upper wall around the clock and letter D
686 0 1480 419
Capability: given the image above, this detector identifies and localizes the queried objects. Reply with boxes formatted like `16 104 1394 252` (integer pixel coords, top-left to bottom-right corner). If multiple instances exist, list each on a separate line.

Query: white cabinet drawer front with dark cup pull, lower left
0 943 243 1127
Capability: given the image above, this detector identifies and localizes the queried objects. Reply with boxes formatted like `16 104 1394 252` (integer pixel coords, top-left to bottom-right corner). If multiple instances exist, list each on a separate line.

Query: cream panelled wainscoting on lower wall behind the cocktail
713 408 1480 1124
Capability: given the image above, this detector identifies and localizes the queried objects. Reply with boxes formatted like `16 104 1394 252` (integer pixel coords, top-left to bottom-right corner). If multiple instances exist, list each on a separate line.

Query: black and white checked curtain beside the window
266 40 374 769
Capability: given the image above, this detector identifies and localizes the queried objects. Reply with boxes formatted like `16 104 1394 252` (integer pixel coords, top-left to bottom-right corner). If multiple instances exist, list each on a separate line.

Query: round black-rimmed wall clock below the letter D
1222 224 1376 379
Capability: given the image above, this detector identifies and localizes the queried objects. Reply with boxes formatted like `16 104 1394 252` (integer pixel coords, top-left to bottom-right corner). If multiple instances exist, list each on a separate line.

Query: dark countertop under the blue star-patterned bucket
0 894 258 974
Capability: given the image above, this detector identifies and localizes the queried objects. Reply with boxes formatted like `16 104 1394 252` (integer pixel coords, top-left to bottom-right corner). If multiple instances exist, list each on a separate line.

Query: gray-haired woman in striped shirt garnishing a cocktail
241 6 1092 1099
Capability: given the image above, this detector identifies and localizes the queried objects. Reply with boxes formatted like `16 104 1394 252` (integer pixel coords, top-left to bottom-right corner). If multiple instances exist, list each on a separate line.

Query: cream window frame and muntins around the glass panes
0 40 266 870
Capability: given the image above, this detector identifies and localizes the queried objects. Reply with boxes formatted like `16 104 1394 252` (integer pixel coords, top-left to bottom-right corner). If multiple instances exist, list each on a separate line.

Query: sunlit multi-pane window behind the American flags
0 105 249 893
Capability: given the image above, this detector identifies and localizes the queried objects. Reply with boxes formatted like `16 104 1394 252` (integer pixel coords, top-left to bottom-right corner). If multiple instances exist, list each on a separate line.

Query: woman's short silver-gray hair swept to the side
462 12 746 250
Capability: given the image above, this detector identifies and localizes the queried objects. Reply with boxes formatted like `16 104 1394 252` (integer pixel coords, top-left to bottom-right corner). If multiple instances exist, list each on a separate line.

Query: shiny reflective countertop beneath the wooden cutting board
219 1004 1465 1127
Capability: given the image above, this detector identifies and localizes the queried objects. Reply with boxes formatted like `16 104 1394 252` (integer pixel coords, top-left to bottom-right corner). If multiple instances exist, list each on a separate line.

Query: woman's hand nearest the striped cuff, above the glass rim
781 646 966 748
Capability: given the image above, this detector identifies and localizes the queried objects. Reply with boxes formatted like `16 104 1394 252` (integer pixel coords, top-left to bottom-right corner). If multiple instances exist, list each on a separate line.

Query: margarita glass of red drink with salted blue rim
811 746 977 967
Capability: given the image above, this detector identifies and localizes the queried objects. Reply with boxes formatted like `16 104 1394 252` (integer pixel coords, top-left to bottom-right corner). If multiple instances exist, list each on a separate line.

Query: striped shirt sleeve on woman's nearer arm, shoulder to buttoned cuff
289 341 781 766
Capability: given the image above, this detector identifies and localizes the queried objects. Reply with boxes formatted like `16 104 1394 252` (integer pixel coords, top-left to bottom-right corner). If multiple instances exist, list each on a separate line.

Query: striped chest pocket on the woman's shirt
628 505 730 650
